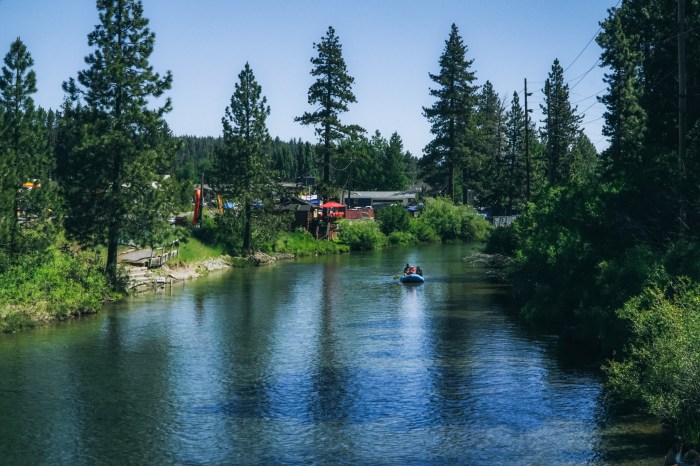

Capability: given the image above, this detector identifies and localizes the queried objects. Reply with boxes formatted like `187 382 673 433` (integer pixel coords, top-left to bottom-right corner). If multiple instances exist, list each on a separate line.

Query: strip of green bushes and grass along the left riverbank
0 198 491 333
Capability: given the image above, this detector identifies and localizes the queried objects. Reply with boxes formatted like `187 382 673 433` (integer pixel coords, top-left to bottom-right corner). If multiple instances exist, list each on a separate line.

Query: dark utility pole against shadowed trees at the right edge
678 0 688 234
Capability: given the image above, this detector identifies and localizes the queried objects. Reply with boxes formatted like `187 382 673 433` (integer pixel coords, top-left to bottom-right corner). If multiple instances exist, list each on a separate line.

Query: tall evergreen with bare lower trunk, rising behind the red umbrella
294 26 364 183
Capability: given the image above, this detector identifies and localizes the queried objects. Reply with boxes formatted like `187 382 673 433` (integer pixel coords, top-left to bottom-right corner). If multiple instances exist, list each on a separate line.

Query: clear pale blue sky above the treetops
0 0 618 156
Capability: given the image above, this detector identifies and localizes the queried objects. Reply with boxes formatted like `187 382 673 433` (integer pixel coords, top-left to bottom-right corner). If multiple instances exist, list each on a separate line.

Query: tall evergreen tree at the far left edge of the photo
0 38 58 258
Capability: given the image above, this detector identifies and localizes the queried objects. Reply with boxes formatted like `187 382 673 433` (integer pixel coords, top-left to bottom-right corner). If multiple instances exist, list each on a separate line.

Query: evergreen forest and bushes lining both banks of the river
0 0 700 443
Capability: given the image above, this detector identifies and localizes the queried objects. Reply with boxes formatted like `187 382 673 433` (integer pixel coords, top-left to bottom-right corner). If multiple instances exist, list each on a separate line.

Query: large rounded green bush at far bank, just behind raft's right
418 198 491 241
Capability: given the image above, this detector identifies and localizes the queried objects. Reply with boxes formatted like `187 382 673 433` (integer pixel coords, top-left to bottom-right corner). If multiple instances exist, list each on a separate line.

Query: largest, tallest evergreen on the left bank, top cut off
61 0 175 278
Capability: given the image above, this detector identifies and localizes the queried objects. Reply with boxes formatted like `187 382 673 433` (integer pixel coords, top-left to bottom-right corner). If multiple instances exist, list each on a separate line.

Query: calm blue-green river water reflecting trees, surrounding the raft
0 245 664 465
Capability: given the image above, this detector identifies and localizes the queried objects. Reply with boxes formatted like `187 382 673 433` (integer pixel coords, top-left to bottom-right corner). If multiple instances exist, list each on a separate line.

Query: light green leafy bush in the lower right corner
606 279 700 444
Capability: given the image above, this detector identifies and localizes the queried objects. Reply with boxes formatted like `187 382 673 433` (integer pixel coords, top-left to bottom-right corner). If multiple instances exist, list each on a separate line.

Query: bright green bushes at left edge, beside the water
0 248 108 332
